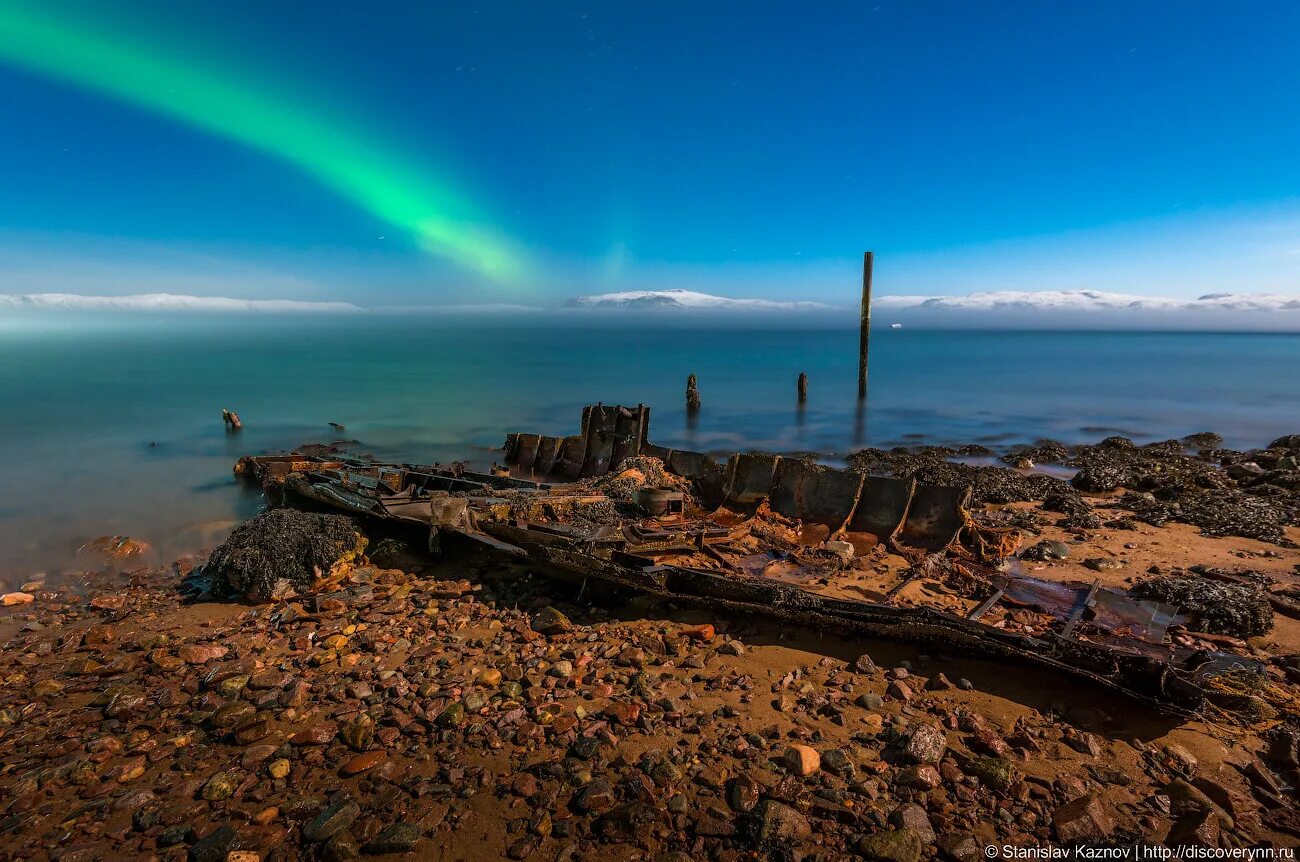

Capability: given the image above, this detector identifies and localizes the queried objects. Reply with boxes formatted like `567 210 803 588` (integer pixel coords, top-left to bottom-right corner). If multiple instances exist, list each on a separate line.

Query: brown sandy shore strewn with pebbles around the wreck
0 439 1300 862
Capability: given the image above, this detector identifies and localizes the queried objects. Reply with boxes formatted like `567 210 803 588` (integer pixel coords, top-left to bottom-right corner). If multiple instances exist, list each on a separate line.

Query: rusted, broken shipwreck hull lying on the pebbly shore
237 404 1205 712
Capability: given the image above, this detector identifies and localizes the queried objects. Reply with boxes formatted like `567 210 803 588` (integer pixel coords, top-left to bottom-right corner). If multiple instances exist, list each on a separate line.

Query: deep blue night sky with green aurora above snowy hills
0 0 1300 316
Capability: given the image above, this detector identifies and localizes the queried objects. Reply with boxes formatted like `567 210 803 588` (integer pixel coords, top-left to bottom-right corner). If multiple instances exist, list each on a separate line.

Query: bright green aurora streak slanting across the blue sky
0 3 523 282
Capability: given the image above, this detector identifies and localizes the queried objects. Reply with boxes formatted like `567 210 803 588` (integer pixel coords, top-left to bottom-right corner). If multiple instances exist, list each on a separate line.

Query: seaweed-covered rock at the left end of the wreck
205 508 365 602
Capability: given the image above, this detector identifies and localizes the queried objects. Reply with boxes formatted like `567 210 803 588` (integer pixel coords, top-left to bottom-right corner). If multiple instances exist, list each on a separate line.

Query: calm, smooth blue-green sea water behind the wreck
0 316 1300 579
